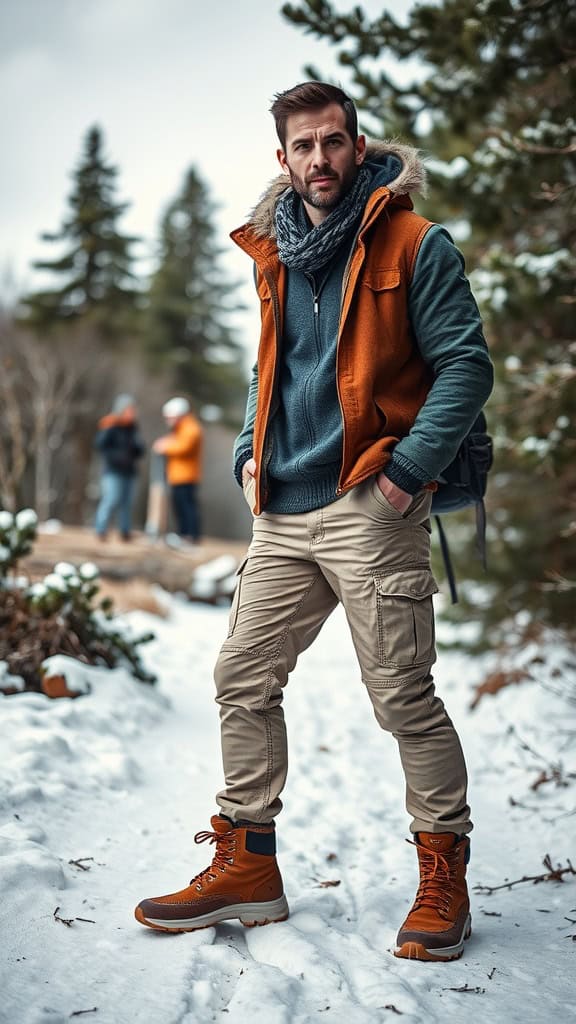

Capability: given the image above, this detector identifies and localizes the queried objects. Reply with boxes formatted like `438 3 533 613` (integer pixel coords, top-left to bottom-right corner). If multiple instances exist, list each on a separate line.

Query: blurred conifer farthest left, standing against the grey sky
22 126 138 336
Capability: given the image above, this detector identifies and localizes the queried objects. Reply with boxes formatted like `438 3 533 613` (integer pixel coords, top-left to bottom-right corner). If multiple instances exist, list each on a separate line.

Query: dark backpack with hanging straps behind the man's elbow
431 413 493 604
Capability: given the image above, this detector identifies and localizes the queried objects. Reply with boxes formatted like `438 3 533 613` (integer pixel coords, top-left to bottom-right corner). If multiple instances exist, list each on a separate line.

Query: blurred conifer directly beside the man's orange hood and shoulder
146 167 245 419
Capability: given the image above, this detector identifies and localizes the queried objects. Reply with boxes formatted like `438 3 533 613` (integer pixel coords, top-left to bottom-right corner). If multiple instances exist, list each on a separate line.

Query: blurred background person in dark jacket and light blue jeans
94 394 145 541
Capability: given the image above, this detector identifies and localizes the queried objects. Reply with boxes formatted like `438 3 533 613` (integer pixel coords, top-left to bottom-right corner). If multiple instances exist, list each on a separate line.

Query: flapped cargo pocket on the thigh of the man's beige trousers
374 567 438 669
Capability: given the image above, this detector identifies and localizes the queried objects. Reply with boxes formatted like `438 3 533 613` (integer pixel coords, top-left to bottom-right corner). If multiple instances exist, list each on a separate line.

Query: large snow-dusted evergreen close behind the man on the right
283 0 576 643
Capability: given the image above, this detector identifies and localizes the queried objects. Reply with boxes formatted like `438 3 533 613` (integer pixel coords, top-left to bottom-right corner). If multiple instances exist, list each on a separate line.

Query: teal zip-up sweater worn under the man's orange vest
230 150 493 513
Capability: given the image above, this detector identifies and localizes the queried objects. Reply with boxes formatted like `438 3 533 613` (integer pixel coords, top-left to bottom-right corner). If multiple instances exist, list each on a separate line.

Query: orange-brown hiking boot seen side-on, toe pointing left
134 814 288 932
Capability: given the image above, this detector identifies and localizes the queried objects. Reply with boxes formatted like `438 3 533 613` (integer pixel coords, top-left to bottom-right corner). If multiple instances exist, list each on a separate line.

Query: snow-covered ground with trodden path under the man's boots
0 600 576 1024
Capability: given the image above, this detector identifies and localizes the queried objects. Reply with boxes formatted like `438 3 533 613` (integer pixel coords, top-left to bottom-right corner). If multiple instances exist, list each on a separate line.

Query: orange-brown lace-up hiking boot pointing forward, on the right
394 833 471 961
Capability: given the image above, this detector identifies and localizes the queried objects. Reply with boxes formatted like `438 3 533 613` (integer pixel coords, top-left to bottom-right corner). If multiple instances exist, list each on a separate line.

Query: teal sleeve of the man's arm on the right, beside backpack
384 225 494 495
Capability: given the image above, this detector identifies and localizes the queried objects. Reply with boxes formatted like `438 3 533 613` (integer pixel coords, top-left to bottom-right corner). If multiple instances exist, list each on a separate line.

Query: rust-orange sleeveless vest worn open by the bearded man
232 186 433 514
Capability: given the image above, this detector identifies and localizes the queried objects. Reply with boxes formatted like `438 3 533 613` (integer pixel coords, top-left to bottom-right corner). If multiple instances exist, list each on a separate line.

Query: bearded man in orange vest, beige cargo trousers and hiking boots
136 82 492 961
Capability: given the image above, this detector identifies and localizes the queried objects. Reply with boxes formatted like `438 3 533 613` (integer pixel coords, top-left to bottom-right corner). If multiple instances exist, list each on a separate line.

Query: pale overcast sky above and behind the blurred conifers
0 0 411 349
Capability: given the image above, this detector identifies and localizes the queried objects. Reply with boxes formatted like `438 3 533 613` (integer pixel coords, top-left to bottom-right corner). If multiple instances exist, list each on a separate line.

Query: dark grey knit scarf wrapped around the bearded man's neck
275 167 372 273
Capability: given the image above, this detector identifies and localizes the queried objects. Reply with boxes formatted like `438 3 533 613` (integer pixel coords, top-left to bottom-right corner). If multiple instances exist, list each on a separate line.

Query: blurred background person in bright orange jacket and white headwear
153 397 203 543
